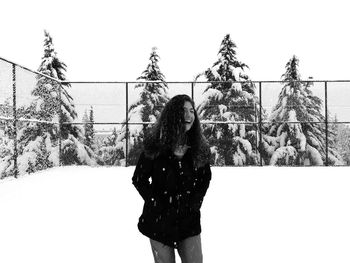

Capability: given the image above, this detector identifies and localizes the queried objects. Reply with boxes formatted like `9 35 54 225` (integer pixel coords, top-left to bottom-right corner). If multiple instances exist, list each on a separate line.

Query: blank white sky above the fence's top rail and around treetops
0 0 350 81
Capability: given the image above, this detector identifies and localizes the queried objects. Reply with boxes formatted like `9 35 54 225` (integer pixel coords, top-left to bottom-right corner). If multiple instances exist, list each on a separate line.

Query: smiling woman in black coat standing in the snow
132 95 211 263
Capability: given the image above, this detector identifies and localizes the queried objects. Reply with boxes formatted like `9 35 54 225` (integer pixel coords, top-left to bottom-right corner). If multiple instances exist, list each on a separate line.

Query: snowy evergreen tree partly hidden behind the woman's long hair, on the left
119 48 169 164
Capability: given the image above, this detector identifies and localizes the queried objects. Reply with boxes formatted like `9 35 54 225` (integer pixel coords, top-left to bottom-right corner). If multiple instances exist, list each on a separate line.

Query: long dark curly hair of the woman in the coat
144 94 210 167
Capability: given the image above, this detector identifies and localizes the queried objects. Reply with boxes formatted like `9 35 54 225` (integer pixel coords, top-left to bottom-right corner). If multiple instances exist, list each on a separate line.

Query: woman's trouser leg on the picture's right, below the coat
178 235 203 263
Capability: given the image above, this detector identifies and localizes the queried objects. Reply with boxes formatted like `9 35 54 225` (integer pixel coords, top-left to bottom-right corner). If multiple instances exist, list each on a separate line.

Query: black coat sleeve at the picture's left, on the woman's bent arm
132 152 153 201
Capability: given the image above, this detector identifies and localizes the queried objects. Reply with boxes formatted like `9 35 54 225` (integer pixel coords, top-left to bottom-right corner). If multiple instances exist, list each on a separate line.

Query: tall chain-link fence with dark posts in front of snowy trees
0 59 350 177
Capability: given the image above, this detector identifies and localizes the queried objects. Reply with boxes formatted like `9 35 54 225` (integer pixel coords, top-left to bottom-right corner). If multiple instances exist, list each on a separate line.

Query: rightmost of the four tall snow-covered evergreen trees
263 56 340 165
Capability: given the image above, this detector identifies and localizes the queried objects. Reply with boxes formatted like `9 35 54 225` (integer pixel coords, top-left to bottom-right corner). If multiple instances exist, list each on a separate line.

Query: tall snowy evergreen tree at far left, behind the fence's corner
14 31 96 176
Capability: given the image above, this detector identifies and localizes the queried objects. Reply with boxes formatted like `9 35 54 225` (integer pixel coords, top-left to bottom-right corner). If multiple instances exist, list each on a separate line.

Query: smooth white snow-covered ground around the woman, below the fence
0 166 350 263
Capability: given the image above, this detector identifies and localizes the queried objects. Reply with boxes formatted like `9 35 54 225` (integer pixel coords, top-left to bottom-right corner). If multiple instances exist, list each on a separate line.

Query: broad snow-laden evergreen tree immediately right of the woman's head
196 35 260 165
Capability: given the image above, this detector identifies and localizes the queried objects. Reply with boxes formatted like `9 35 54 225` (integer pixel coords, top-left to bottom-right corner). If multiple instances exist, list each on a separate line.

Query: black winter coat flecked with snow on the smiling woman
132 149 211 248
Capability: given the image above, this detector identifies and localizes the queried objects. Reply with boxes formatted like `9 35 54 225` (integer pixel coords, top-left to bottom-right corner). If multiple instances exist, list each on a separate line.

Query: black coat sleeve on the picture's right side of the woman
189 163 211 210
